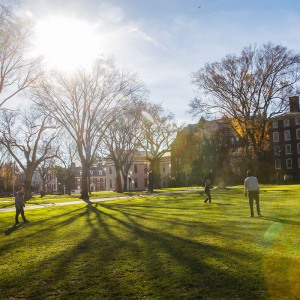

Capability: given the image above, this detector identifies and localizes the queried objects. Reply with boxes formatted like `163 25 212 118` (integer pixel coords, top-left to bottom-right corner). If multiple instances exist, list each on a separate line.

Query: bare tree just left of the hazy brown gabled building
140 104 178 188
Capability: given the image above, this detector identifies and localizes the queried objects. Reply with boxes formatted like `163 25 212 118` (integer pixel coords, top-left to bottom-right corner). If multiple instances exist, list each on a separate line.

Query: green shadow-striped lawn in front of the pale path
0 186 300 299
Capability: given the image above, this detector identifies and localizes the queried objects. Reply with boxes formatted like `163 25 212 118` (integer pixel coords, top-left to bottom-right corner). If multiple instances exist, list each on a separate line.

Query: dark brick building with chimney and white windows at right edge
270 96 300 183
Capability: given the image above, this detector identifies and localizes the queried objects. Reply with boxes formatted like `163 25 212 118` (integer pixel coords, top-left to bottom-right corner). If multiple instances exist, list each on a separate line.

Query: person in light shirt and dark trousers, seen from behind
244 170 261 217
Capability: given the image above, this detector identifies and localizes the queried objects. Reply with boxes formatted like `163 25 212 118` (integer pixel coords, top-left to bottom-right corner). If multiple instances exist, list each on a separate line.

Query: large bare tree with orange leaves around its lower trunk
190 43 300 170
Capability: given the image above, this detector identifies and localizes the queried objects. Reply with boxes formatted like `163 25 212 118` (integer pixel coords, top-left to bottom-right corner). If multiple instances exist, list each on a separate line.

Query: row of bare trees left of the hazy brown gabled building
0 3 177 199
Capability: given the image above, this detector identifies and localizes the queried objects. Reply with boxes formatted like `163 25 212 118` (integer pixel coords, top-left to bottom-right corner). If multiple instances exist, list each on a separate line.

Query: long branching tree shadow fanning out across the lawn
0 201 270 299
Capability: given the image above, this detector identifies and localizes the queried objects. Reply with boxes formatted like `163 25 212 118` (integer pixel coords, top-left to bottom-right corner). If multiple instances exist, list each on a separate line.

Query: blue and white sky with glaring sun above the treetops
21 0 300 124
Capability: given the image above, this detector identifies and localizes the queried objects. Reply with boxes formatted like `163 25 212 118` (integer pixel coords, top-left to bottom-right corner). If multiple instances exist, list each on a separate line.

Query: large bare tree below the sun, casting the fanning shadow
33 59 144 200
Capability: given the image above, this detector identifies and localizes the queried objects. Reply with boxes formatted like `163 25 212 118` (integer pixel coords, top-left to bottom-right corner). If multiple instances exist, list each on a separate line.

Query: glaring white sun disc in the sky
33 16 100 72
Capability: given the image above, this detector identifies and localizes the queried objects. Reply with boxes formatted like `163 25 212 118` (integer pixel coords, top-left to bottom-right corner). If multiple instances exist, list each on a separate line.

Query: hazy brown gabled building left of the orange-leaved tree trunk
171 117 243 186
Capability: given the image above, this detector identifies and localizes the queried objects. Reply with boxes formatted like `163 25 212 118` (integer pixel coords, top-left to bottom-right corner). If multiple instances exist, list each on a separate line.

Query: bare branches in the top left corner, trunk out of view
0 3 40 108
